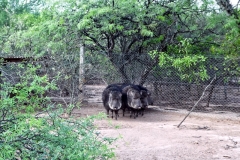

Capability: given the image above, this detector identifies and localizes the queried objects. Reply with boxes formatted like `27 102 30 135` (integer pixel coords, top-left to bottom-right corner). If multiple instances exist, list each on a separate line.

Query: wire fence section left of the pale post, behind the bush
0 54 80 106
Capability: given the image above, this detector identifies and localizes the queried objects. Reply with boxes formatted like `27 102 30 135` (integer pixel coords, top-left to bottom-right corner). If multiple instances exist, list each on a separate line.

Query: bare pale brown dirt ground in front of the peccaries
75 106 240 160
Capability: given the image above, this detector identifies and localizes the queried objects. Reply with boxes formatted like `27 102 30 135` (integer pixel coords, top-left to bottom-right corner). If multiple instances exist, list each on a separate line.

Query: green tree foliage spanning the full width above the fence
0 0 239 84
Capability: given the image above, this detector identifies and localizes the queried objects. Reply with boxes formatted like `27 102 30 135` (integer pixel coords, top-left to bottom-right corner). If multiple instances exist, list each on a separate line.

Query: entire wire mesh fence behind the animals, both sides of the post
1 52 240 117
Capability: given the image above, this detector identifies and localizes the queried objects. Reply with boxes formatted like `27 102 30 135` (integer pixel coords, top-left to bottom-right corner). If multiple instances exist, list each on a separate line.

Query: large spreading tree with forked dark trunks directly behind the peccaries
70 0 228 84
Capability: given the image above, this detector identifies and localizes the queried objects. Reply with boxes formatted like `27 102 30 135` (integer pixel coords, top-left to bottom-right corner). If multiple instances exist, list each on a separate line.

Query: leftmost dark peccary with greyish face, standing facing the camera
102 85 122 120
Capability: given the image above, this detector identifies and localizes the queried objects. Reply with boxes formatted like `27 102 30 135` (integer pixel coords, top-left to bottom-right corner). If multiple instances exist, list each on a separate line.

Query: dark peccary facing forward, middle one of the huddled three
122 84 143 118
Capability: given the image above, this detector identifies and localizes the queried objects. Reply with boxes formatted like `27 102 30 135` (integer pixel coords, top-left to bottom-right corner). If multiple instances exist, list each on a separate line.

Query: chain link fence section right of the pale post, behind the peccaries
84 54 240 113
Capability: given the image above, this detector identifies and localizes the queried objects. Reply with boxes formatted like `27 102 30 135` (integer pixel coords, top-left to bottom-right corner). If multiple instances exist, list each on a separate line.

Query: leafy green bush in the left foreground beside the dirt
0 66 114 160
